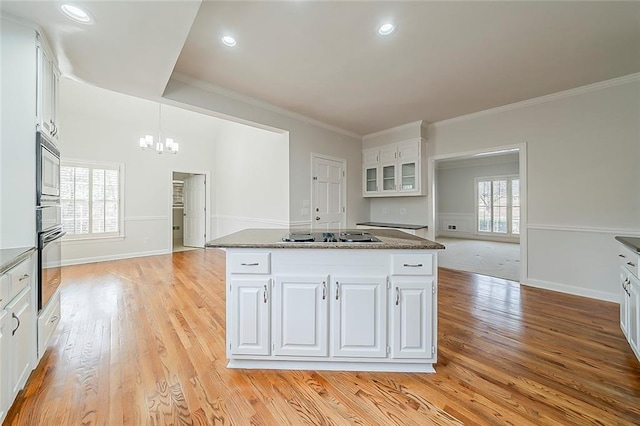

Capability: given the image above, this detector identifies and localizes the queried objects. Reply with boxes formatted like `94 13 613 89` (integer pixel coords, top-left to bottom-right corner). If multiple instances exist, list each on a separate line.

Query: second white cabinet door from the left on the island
272 276 329 356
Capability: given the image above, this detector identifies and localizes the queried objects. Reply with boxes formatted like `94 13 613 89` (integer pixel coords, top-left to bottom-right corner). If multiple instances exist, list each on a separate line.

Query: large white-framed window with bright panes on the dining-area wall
60 162 122 238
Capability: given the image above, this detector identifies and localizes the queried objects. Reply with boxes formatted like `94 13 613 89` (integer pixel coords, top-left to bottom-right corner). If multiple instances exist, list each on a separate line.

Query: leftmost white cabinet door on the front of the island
227 278 271 355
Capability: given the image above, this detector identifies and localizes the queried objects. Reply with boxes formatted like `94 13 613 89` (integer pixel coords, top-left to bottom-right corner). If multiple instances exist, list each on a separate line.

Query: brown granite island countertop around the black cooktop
205 229 445 250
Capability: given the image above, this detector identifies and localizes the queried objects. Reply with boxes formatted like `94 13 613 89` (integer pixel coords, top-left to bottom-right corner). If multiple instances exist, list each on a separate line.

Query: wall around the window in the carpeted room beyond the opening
435 154 519 241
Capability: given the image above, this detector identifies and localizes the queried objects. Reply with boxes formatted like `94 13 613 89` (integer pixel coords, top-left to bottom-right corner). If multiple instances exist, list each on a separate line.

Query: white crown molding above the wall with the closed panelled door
171 72 362 140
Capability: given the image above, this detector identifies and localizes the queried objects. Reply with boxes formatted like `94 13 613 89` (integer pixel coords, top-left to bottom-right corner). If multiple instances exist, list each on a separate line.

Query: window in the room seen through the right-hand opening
476 176 520 236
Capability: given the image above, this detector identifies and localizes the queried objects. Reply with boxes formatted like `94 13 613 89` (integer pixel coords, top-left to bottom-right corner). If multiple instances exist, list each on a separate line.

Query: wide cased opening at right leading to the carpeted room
429 144 527 282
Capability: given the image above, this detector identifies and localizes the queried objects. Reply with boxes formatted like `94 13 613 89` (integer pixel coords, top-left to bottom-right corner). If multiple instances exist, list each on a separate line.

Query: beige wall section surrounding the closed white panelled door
163 77 369 227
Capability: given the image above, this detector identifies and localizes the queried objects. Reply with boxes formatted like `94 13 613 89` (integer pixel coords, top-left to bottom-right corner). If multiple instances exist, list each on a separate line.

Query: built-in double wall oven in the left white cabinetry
36 132 65 312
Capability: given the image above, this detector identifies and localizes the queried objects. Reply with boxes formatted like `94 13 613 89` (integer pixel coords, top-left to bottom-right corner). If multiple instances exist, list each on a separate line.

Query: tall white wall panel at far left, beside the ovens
0 17 37 248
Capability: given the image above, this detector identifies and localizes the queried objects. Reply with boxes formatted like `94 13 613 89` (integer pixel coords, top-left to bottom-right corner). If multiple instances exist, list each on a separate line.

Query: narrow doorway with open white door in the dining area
171 171 207 252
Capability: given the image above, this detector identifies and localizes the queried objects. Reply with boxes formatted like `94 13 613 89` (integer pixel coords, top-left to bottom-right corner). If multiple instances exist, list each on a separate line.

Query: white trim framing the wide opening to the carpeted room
427 142 529 283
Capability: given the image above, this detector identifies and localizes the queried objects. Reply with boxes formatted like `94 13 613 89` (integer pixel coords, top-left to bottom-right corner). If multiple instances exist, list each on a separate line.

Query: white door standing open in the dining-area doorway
182 175 206 248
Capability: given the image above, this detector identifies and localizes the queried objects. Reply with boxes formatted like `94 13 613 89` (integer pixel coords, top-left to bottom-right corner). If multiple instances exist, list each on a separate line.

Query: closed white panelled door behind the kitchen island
311 156 346 231
